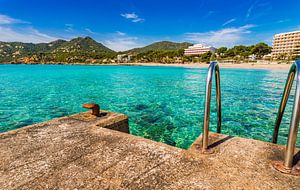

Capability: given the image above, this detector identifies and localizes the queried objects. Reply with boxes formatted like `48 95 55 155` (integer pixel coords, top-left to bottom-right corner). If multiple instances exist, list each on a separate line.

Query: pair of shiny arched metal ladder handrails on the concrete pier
202 60 300 175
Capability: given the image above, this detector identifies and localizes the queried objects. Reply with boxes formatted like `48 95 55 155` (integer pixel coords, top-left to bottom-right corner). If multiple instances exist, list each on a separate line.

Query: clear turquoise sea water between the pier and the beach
0 65 300 148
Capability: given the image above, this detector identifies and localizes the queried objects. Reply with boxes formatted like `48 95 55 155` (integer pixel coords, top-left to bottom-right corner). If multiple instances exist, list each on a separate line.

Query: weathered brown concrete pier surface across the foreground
0 111 300 190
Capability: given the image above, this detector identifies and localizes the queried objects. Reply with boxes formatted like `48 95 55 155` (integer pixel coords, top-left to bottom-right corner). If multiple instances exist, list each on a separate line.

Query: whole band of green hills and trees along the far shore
0 37 300 63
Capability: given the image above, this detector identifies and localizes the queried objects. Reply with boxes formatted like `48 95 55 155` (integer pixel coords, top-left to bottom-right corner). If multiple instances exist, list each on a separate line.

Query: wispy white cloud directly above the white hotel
185 24 254 47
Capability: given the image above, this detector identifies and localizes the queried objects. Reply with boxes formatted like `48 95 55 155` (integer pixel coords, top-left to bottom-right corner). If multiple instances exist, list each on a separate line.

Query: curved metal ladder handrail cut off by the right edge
272 60 300 168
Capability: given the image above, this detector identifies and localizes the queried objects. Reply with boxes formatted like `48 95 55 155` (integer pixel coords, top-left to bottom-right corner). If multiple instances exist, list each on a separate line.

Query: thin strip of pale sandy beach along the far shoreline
0 63 291 70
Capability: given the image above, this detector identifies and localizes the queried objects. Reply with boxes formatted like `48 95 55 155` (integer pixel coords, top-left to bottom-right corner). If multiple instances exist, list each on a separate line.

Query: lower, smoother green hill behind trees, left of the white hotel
127 41 193 53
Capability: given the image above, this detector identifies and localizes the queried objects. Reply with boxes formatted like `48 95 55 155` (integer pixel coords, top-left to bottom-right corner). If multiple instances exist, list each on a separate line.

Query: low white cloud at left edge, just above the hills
0 26 57 43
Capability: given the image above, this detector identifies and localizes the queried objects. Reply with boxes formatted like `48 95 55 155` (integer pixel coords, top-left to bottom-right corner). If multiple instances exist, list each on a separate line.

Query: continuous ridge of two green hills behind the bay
0 36 192 62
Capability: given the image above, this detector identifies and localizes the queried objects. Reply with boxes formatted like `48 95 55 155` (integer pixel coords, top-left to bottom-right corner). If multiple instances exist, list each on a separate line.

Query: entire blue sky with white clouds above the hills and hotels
0 0 300 50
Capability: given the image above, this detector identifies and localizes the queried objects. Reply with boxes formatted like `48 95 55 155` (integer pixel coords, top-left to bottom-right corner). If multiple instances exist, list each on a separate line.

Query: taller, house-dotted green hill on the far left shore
0 37 116 63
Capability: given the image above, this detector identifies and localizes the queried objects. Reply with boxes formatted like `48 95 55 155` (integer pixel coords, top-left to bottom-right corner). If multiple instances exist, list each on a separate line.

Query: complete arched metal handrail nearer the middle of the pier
202 61 222 153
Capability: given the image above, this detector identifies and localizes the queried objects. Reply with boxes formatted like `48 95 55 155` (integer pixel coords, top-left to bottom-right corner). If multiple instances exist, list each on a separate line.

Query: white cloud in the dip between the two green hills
104 31 144 51
